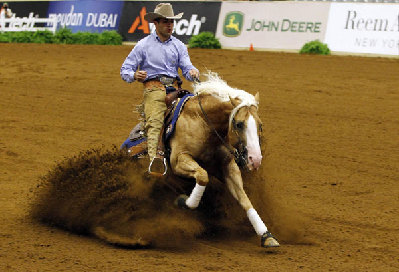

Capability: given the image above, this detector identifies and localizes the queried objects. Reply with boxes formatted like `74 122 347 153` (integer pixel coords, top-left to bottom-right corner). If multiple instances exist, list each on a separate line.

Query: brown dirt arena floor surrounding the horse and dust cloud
0 44 399 272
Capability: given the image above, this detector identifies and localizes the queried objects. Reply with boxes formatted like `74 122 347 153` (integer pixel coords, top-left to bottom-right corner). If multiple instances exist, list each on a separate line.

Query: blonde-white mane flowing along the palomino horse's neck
194 72 258 130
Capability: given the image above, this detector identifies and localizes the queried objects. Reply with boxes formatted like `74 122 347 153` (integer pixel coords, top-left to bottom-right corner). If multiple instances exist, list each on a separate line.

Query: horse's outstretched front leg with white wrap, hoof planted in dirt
223 159 280 247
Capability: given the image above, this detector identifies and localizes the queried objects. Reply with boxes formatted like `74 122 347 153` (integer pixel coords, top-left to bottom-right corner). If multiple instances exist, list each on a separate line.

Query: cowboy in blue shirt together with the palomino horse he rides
121 4 279 248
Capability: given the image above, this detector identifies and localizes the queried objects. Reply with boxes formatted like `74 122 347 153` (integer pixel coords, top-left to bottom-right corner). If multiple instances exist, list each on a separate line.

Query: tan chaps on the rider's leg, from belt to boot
143 82 166 159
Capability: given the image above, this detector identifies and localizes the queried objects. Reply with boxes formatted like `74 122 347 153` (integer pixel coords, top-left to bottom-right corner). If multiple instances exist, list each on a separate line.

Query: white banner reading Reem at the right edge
325 3 399 55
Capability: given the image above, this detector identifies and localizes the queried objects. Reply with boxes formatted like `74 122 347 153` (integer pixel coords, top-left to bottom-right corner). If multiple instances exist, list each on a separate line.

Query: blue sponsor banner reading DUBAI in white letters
47 0 123 32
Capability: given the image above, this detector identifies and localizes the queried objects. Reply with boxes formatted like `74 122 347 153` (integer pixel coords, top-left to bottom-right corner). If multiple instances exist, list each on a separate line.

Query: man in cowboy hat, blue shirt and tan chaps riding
120 3 199 173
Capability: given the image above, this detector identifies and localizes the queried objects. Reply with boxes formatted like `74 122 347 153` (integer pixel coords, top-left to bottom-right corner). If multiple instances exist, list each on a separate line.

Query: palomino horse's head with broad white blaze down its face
228 93 262 170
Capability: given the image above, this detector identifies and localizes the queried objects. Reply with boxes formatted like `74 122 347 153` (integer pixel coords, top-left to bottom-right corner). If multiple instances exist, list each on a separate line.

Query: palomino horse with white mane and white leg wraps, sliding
170 74 279 247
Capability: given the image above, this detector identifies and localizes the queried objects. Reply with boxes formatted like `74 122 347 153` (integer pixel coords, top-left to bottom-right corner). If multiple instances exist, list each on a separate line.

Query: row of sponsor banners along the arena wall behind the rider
1 0 399 56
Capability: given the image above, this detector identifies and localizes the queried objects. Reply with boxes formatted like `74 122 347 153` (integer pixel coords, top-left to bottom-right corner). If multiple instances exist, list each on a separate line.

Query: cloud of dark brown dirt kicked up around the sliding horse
31 147 305 248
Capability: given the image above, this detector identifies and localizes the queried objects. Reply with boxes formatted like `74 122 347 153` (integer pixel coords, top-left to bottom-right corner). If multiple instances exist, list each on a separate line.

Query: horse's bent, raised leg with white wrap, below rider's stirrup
171 153 209 209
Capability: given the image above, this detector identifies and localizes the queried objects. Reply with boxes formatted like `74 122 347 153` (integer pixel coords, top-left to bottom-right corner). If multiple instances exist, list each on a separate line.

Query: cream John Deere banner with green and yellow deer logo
216 2 329 49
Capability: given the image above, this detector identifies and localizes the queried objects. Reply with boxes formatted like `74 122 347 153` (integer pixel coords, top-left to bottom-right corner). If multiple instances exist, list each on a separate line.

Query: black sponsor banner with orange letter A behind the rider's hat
119 1 221 43
